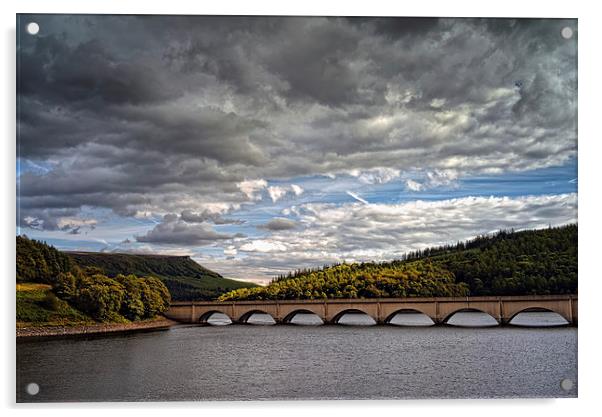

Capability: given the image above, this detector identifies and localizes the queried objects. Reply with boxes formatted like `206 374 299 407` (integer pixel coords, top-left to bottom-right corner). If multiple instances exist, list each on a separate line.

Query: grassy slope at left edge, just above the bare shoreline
17 283 95 328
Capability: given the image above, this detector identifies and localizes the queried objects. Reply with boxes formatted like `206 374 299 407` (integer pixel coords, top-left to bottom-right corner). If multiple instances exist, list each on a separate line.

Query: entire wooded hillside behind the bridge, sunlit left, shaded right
220 225 577 300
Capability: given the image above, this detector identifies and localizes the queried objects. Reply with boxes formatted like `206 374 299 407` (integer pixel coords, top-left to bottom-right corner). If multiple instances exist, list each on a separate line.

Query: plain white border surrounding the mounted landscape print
0 0 602 417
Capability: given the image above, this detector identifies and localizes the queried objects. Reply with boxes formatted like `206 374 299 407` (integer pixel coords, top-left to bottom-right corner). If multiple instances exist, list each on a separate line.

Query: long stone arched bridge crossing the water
165 295 577 325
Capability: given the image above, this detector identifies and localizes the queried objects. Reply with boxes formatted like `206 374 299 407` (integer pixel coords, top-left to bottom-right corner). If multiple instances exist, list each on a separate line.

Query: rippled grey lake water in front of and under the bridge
17 313 577 402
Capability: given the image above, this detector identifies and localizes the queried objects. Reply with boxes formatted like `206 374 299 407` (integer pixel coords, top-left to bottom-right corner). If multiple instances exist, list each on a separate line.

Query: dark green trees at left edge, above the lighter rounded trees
17 236 71 284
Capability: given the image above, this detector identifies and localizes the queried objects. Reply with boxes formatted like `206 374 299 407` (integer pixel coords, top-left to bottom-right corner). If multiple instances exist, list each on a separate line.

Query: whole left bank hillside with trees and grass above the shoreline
16 236 171 328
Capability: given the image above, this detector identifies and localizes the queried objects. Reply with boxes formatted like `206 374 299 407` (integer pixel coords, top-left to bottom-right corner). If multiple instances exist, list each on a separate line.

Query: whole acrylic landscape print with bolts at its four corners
16 14 578 402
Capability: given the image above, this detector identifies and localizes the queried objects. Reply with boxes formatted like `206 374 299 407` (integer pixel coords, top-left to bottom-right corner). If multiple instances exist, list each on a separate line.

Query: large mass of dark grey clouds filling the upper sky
17 15 577 231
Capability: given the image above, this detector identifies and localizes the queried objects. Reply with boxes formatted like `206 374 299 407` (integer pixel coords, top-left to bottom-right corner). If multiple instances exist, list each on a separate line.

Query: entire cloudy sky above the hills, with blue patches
17 15 578 283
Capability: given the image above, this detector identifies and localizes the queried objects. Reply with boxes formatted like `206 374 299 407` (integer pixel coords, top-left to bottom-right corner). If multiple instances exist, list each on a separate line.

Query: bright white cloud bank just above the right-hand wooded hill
214 193 577 279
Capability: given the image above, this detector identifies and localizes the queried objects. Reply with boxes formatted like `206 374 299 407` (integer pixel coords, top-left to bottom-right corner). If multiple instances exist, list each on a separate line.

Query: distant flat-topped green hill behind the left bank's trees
63 251 256 301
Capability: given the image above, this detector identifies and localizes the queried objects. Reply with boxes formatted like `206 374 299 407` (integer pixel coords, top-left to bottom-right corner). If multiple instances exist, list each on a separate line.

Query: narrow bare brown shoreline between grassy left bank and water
16 317 177 342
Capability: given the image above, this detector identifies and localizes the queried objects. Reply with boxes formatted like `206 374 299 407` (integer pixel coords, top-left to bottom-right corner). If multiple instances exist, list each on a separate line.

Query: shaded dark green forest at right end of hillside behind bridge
422 224 578 295
